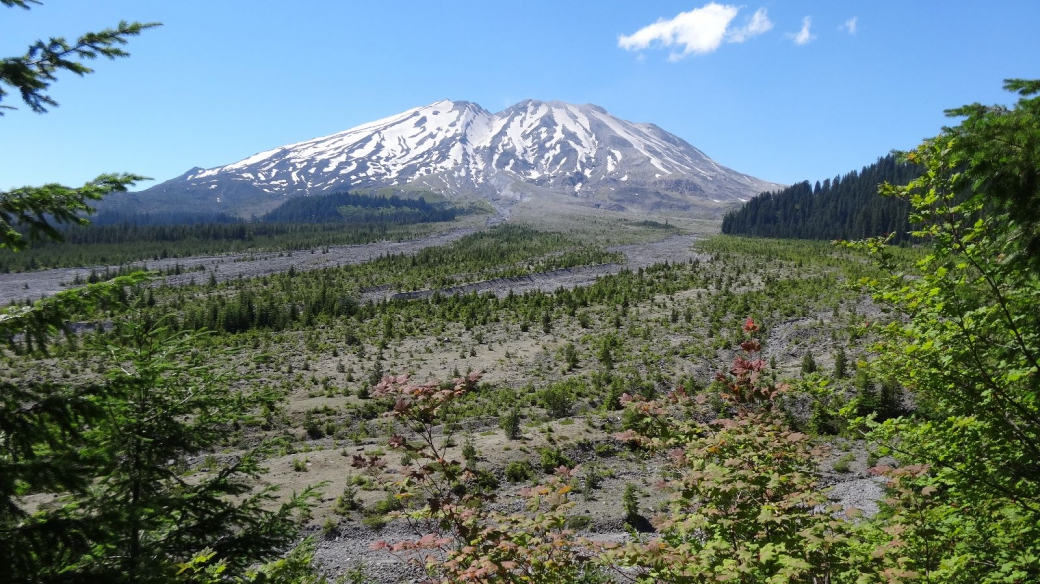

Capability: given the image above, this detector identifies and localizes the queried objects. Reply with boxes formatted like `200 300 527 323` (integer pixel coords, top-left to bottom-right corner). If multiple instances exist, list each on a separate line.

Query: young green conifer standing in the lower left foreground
76 318 315 582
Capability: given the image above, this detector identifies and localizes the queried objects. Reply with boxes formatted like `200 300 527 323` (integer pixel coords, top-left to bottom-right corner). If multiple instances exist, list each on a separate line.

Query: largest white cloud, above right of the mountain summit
618 2 773 61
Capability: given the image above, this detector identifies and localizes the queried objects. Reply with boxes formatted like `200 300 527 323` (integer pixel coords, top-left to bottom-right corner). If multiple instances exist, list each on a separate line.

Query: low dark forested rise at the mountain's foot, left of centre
262 192 459 224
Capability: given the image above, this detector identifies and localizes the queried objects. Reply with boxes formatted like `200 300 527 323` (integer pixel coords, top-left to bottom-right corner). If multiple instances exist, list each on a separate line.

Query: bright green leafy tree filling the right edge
840 80 1040 583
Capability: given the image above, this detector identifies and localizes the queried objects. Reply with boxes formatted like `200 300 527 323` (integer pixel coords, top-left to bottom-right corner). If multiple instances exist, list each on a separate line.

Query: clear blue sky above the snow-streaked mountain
0 0 1040 189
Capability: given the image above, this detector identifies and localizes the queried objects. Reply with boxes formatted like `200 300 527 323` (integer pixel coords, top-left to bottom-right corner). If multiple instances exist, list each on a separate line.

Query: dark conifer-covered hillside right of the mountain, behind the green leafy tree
722 155 920 243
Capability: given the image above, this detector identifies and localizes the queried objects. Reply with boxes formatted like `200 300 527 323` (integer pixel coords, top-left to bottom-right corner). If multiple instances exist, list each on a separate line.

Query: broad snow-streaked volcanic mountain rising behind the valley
110 100 780 217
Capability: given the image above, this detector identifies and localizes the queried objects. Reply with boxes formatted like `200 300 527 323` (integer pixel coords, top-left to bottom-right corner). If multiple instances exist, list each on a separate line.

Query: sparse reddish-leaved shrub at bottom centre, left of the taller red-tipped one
366 372 591 584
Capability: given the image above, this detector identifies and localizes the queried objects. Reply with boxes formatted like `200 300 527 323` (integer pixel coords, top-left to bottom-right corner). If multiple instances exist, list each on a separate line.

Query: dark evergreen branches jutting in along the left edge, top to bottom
0 5 156 582
